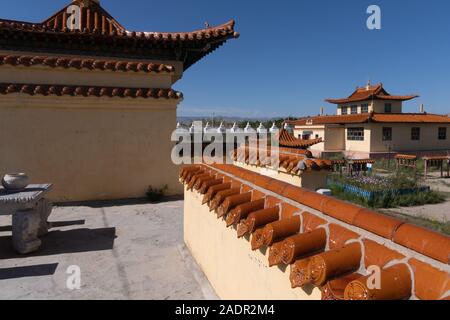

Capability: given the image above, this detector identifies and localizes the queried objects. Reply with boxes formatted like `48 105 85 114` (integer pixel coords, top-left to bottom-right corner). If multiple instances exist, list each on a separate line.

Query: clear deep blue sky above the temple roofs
0 0 450 117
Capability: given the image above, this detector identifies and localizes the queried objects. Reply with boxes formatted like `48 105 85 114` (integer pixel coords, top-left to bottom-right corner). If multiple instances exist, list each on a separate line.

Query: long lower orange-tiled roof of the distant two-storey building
287 113 450 126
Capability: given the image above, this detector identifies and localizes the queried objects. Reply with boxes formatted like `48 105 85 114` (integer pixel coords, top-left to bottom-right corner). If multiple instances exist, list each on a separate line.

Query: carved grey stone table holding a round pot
0 184 52 254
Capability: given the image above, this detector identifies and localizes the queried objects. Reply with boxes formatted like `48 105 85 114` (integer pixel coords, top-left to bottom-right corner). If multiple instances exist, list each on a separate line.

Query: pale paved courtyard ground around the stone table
0 201 217 300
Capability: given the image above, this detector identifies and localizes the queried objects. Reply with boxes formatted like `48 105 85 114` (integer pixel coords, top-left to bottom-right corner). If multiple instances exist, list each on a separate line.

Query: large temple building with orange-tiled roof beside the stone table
0 0 239 201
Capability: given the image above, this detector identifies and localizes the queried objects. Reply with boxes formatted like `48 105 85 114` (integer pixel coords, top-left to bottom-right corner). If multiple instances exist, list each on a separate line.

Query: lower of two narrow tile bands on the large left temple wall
0 83 183 100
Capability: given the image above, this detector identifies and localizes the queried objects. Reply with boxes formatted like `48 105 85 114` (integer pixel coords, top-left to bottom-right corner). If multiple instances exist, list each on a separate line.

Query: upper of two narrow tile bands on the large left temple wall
0 55 175 73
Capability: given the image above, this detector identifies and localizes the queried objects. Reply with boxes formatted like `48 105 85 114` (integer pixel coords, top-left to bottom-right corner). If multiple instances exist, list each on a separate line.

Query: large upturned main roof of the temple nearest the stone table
0 0 239 70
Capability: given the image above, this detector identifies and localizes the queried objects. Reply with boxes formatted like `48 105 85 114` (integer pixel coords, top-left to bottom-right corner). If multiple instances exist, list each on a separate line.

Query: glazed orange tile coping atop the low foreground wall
180 164 450 300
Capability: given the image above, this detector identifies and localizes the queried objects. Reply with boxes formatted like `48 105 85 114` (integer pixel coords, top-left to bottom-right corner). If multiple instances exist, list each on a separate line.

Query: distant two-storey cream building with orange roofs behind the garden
288 83 450 159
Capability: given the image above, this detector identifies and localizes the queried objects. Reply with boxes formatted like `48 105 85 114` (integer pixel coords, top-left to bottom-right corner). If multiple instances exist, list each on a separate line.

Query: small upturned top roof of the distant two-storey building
325 83 418 104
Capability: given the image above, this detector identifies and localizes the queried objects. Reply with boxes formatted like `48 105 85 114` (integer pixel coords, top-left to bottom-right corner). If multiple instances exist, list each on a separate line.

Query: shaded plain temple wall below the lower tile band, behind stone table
0 94 182 201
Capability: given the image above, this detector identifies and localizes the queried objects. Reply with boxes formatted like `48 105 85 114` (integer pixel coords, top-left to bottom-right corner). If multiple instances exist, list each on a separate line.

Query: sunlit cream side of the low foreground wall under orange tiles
184 190 321 300
